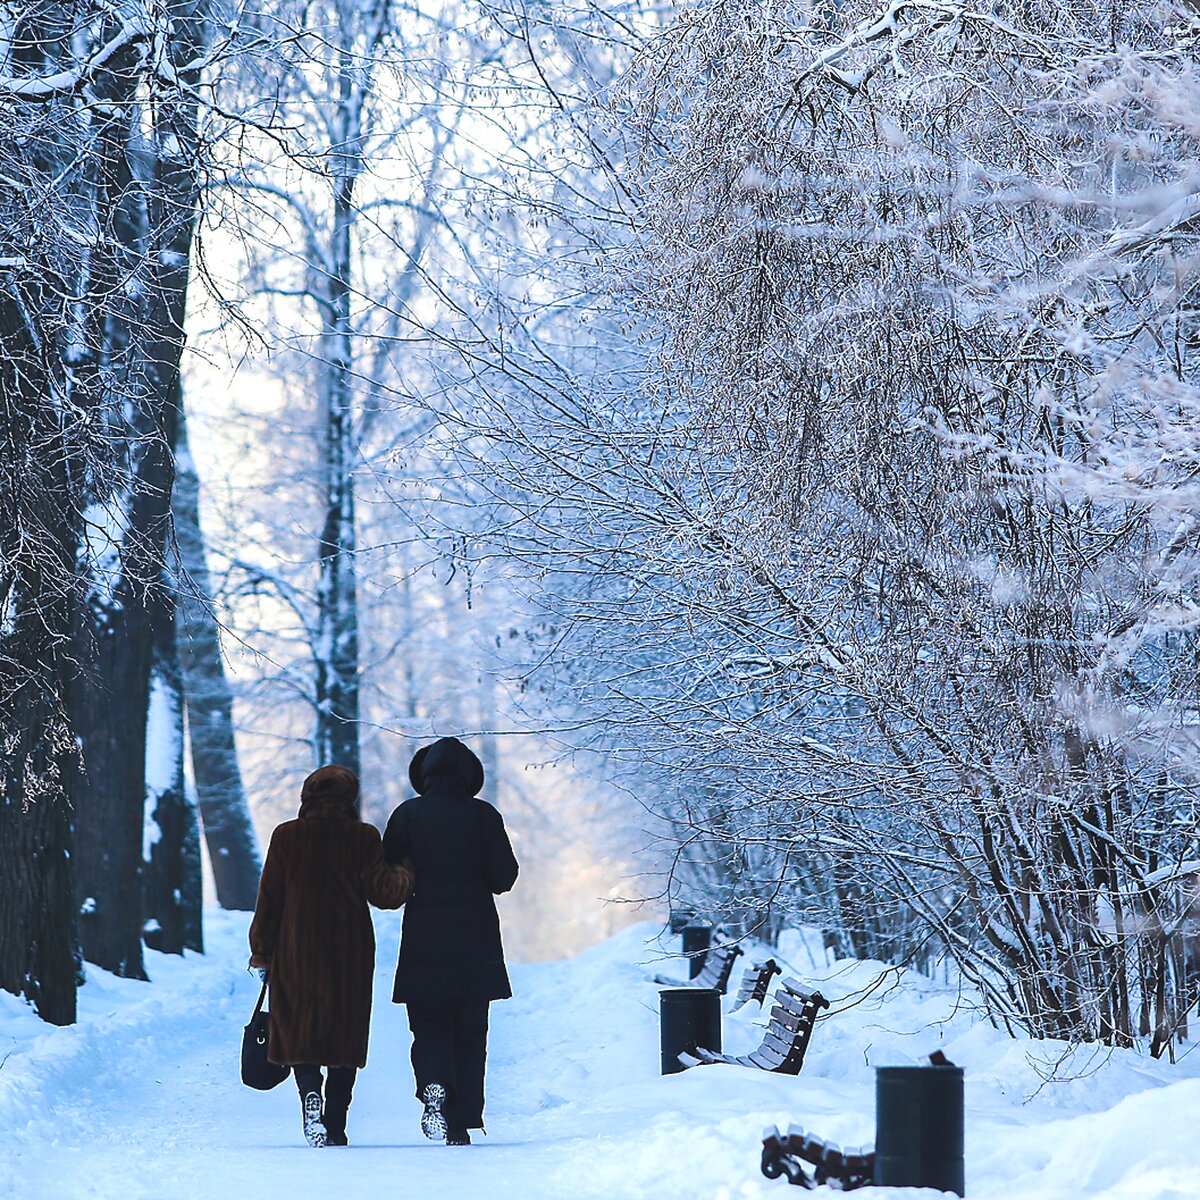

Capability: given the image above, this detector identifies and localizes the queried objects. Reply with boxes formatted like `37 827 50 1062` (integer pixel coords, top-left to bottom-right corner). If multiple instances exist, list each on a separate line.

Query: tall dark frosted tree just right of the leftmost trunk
62 2 216 976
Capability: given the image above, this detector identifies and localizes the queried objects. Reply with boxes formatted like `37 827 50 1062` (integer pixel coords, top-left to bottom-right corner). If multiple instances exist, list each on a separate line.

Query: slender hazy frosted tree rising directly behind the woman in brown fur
189 2 462 792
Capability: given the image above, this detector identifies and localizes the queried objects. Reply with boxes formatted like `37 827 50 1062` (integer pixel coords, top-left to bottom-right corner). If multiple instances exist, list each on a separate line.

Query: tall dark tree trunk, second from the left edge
76 4 204 978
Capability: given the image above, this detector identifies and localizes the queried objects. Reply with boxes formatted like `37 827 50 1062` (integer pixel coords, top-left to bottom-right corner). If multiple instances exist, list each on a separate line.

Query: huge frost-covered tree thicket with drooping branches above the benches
398 0 1198 1054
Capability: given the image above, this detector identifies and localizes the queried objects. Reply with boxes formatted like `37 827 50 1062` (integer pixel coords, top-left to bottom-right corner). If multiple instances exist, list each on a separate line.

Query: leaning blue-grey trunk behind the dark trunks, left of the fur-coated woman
173 406 262 912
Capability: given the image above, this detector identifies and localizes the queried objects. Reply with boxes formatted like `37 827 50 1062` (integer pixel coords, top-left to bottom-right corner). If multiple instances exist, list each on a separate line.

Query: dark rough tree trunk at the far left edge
0 272 82 1025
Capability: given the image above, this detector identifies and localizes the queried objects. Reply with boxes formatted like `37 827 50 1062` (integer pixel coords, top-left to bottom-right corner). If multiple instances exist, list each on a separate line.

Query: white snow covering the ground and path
0 912 1200 1200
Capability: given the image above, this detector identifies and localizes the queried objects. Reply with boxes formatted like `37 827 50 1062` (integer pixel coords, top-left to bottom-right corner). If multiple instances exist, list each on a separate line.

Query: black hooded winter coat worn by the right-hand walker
383 738 517 1004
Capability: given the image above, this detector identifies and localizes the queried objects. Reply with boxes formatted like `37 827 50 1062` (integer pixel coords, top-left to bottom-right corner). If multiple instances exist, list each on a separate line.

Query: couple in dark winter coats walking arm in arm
250 738 517 1146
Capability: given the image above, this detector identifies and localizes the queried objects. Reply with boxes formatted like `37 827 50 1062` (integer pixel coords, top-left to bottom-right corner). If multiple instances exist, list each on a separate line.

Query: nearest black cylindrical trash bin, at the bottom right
875 1066 966 1196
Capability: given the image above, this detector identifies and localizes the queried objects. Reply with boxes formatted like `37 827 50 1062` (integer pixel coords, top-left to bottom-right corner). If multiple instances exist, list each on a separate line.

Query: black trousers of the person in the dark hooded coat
408 1000 488 1130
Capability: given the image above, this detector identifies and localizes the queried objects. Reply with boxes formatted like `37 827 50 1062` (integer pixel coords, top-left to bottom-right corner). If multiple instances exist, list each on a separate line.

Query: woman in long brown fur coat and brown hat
250 767 413 1146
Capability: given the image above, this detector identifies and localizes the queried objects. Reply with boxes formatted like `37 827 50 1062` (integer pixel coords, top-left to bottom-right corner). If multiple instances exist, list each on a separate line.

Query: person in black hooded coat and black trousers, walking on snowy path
383 738 517 1146
